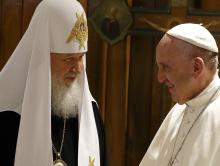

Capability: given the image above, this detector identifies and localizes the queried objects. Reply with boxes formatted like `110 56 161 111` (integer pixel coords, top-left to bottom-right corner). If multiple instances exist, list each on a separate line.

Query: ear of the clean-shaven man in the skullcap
193 57 205 78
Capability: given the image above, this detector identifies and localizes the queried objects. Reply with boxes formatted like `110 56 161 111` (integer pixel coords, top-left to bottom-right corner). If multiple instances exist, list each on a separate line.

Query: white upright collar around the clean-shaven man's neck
186 70 220 110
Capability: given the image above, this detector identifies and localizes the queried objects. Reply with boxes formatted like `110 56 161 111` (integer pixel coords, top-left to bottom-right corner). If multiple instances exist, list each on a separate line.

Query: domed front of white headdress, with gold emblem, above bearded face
44 0 88 53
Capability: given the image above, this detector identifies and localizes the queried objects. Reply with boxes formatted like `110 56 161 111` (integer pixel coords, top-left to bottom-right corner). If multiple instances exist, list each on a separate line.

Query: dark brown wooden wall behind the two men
0 0 220 166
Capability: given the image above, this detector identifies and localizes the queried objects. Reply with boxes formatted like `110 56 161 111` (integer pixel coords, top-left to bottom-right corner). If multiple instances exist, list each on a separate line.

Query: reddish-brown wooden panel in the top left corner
1 0 22 68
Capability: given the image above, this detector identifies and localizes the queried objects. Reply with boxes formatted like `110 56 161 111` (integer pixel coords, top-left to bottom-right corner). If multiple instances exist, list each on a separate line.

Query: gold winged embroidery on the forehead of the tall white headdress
66 13 88 49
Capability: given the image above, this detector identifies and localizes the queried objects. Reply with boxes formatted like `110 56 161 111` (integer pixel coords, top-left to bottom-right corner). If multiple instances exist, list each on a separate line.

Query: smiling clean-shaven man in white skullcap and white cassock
140 23 220 166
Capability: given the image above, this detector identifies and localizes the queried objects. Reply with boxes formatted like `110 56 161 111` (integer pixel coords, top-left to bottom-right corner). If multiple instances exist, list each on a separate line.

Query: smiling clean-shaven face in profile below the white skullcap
156 35 194 104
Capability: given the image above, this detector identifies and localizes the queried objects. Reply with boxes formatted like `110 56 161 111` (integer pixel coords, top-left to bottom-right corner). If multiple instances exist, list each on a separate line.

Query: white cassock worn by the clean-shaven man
139 73 220 166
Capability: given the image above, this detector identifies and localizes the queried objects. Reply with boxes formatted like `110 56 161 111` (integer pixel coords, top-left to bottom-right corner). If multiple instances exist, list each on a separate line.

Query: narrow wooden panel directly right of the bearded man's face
86 24 107 120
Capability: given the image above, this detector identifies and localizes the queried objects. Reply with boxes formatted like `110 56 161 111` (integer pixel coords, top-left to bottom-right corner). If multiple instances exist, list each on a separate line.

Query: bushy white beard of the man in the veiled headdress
51 74 82 118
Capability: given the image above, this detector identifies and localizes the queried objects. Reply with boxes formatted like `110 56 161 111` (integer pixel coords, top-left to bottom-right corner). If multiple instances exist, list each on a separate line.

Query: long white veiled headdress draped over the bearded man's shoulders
0 0 100 166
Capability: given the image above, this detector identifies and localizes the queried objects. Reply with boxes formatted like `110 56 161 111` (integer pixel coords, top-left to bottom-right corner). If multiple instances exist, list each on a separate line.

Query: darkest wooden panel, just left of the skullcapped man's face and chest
126 36 154 166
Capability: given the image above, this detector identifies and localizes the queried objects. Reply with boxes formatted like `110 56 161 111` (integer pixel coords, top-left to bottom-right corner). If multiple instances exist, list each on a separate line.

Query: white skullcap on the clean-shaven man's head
166 23 218 53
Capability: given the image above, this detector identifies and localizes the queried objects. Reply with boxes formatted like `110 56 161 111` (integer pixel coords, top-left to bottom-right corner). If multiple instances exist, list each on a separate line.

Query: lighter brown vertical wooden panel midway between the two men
105 41 127 166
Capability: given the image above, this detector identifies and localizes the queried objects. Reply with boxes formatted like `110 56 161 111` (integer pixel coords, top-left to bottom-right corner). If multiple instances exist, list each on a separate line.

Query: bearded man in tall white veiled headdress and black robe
0 0 106 166
